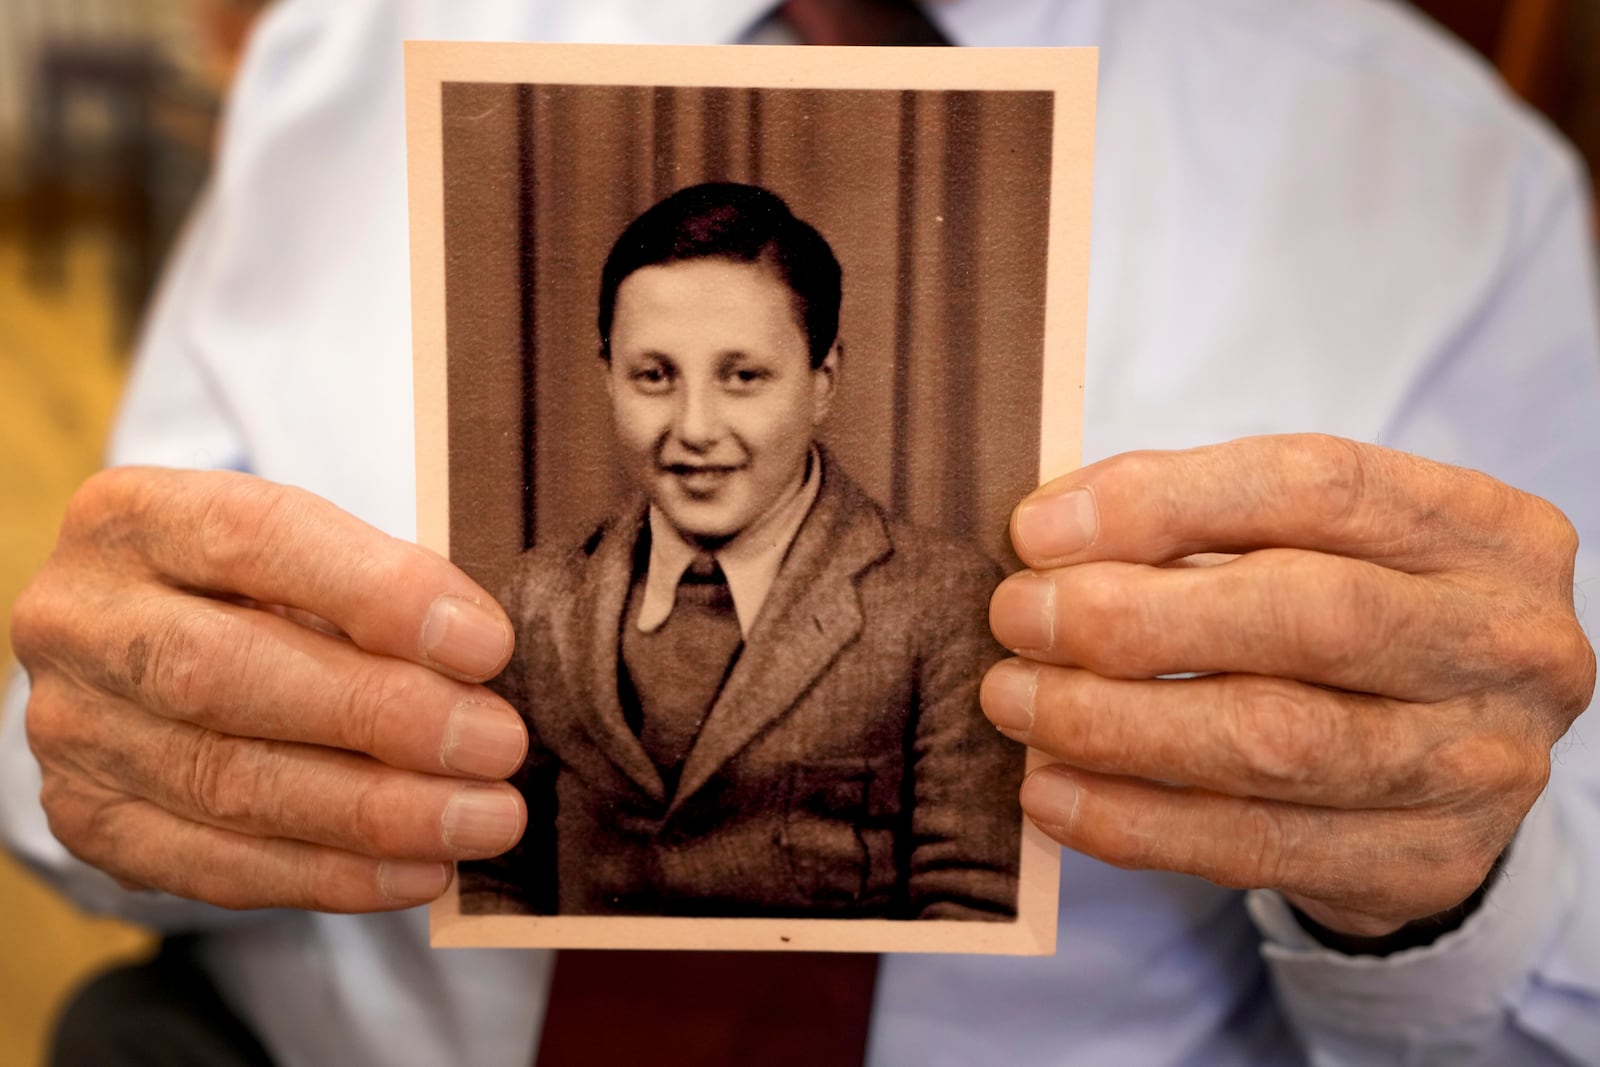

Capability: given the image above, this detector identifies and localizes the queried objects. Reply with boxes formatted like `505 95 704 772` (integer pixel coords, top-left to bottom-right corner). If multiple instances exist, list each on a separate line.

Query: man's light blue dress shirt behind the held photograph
0 0 1600 1067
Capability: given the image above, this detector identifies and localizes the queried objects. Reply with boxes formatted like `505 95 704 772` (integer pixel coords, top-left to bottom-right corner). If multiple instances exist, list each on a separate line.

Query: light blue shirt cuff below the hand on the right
1246 795 1578 1038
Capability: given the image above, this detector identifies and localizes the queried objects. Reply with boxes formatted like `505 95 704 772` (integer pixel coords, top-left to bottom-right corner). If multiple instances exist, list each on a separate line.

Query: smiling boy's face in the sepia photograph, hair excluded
608 259 837 542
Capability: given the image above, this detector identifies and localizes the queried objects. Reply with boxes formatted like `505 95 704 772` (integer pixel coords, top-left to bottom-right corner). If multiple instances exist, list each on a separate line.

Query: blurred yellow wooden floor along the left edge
0 234 149 1067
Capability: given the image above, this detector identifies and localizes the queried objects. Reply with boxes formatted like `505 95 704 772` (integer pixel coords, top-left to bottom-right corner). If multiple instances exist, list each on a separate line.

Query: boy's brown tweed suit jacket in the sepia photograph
461 461 1024 918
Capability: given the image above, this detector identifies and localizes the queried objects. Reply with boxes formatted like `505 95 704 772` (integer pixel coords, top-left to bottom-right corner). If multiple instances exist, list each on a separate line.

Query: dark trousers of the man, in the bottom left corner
50 937 272 1067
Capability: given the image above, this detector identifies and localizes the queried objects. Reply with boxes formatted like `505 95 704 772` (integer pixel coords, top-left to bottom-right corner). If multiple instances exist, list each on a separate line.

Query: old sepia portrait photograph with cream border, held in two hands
408 43 1093 953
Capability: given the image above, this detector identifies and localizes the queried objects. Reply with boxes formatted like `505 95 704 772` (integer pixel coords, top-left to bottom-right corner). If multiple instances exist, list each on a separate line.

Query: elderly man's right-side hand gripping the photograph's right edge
982 437 1595 937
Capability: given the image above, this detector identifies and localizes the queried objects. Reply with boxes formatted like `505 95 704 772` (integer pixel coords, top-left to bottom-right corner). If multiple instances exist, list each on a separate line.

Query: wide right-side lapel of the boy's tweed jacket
662 459 890 814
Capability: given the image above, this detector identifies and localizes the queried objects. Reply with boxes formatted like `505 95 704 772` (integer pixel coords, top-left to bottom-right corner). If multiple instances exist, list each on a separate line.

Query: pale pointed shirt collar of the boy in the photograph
638 448 822 638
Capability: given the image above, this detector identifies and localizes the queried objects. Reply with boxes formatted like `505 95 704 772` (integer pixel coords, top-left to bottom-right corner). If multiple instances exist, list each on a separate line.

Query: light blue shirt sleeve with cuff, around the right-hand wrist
1248 123 1600 1067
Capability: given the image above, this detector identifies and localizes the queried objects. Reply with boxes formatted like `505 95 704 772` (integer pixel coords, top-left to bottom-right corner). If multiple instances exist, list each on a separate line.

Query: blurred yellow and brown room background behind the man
0 0 1600 1067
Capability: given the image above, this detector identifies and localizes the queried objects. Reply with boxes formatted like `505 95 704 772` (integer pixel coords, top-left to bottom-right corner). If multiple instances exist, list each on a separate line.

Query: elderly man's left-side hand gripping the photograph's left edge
13 469 528 912
